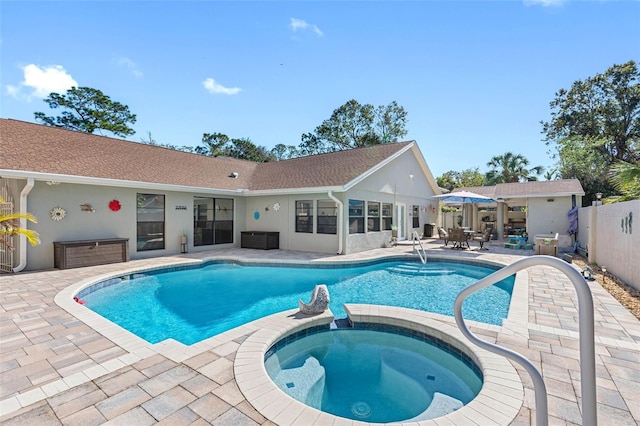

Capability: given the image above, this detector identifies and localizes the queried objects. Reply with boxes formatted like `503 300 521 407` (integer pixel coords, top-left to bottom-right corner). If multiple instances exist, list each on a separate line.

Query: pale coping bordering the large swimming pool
54 254 529 362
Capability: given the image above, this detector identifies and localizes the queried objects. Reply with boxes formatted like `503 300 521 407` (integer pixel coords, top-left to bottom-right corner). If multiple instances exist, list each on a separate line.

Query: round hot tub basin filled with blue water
265 325 482 423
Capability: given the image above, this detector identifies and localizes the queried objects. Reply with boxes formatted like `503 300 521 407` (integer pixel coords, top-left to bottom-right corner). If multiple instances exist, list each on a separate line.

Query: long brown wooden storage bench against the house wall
53 238 129 269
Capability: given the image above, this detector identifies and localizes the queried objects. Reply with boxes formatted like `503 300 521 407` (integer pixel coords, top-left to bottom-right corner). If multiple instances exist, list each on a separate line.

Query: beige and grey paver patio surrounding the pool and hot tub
0 240 640 425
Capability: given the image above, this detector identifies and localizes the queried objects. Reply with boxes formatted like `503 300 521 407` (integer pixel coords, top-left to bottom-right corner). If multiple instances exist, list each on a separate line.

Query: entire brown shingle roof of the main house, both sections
0 119 415 191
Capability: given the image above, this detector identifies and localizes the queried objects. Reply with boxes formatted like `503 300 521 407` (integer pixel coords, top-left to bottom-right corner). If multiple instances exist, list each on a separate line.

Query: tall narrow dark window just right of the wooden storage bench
136 194 164 251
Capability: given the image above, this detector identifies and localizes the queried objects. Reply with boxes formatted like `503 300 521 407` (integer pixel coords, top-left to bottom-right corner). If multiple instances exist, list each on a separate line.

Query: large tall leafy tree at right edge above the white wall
541 61 640 205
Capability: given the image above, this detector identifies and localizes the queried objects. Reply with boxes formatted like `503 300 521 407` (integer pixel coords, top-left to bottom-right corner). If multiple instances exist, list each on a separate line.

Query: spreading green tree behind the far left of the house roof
34 87 136 137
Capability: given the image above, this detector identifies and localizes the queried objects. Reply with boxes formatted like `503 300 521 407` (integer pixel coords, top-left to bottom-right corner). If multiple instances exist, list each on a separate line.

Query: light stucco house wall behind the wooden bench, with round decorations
21 181 244 270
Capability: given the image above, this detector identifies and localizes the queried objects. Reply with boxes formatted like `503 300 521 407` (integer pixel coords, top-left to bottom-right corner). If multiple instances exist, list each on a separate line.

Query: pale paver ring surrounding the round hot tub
234 304 524 426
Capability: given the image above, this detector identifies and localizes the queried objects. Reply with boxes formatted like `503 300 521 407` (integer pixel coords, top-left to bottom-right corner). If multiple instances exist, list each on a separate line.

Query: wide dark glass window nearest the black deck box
193 197 233 246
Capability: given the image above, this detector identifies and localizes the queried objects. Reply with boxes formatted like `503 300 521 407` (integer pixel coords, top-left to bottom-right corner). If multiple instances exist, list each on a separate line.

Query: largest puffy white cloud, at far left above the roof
7 64 78 100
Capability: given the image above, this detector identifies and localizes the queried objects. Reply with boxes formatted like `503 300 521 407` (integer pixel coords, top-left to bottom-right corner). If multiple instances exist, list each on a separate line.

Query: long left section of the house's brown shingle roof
0 119 256 190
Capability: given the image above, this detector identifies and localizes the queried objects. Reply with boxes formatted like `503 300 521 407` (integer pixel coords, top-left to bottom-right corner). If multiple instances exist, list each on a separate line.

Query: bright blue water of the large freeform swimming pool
79 262 514 345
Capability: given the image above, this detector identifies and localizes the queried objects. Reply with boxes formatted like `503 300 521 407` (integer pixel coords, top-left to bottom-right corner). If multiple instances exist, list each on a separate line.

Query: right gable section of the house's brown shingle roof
249 142 414 191
